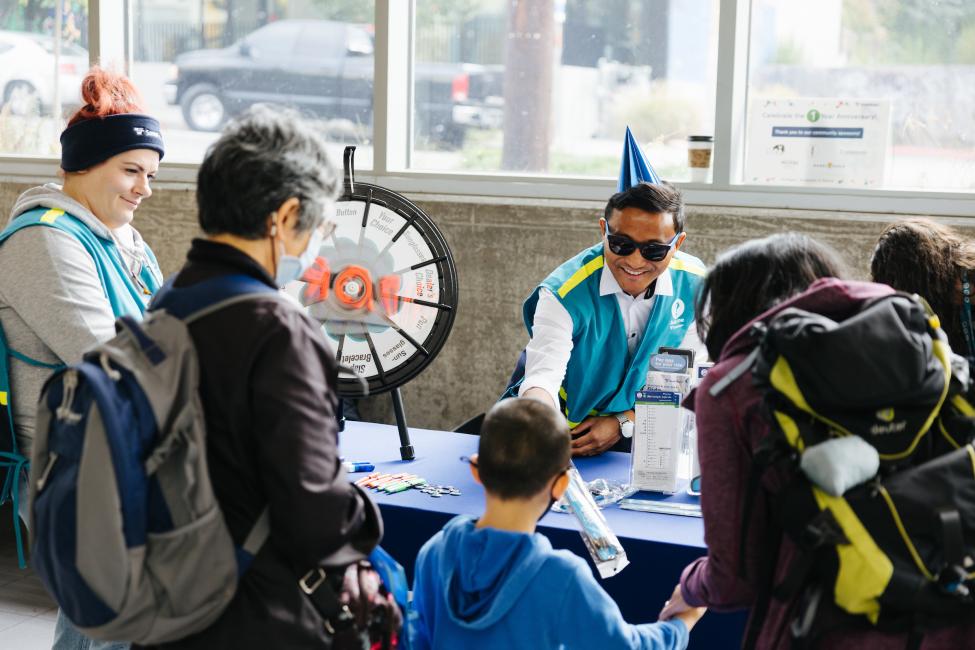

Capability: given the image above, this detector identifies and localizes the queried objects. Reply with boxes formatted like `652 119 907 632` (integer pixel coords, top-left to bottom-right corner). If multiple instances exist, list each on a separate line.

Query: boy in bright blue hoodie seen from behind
410 398 704 650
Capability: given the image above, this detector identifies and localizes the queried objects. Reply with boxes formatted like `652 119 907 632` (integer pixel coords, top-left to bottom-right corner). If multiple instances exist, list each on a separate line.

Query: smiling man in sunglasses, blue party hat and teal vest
505 128 705 456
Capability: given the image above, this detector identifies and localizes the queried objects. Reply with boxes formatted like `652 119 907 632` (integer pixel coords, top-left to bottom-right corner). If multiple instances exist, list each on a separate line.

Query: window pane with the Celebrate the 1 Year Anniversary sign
742 0 975 190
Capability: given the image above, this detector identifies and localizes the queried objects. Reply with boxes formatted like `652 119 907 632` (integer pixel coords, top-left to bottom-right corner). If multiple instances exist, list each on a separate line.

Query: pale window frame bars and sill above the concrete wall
0 0 975 217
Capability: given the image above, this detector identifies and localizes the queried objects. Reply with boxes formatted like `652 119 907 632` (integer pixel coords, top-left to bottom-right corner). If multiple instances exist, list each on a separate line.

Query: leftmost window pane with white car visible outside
0 0 88 157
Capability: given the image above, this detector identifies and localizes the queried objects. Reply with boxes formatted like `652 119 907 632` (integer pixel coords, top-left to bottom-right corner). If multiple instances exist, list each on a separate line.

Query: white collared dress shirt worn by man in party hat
518 267 707 406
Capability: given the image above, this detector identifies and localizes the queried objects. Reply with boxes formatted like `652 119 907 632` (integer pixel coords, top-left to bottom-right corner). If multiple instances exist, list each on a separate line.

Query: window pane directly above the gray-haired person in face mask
130 0 375 169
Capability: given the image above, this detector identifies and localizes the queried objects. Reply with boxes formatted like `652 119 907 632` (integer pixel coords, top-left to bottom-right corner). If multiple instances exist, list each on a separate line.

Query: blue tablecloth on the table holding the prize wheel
340 422 745 649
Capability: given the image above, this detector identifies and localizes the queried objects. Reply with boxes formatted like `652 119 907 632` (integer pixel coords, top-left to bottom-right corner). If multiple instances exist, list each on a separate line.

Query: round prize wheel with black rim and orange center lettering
298 147 457 398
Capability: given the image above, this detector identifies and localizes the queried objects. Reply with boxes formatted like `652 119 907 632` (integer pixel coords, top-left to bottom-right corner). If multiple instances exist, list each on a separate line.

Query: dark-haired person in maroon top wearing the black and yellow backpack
660 234 975 650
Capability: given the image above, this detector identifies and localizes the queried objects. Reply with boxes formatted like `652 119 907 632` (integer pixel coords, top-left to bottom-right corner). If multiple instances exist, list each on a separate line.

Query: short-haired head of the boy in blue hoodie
475 397 571 500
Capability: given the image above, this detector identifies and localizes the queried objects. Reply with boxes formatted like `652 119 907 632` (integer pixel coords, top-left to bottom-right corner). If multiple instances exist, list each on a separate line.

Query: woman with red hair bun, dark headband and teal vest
0 68 164 650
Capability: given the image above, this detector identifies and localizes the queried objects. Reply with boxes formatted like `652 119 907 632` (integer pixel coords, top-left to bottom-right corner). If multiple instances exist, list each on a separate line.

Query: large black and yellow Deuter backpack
710 293 975 647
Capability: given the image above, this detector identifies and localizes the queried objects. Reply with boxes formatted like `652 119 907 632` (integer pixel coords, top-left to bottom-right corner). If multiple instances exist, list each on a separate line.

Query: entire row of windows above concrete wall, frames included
0 0 975 216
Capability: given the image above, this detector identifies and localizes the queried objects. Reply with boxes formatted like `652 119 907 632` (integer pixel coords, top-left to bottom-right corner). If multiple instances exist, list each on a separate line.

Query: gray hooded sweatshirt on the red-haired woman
0 183 159 456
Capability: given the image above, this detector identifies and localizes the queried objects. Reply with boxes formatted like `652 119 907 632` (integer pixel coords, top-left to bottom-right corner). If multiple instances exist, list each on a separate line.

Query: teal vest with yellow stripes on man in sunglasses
523 243 706 426
